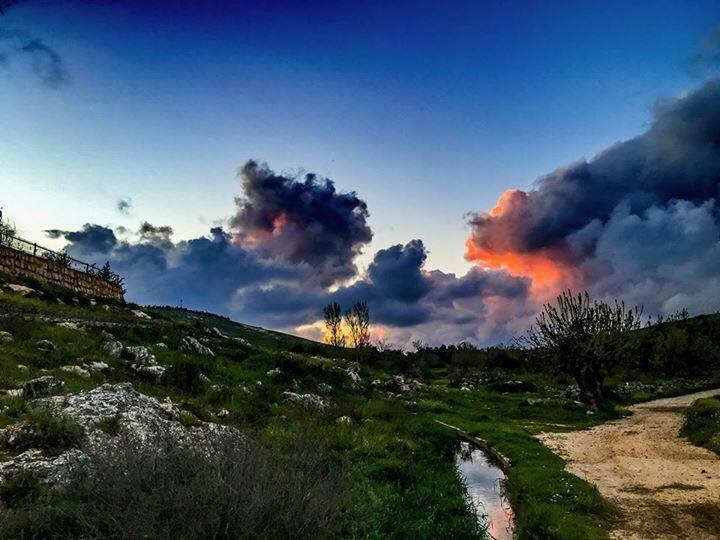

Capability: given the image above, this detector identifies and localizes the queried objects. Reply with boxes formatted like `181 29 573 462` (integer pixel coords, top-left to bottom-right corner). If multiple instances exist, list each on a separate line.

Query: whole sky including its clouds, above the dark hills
0 0 720 344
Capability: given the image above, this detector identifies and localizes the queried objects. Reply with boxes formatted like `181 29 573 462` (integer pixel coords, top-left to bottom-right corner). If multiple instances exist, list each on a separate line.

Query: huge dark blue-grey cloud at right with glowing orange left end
468 79 720 318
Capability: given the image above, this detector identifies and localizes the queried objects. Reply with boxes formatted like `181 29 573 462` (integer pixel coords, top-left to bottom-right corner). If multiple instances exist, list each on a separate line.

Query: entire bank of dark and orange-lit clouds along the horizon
48 79 720 345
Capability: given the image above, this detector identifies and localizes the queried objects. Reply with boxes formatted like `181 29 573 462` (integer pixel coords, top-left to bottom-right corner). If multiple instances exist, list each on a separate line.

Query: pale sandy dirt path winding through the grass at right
538 390 720 540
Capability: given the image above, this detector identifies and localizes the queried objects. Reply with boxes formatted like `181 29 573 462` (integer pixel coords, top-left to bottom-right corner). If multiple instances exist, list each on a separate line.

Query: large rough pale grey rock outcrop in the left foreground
0 383 245 483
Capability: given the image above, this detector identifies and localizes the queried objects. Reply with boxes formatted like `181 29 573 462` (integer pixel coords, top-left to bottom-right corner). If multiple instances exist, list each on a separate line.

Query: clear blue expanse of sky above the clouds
0 0 720 272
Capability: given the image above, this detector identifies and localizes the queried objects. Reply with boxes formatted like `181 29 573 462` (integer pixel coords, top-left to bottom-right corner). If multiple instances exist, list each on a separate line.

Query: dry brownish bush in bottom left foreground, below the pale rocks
0 439 344 539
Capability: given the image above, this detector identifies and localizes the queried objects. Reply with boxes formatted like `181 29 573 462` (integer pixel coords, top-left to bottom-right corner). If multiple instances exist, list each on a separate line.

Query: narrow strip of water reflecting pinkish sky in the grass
455 441 515 540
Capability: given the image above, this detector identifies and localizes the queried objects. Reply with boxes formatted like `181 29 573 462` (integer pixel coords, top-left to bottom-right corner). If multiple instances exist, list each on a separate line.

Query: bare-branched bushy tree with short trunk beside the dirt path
527 290 642 406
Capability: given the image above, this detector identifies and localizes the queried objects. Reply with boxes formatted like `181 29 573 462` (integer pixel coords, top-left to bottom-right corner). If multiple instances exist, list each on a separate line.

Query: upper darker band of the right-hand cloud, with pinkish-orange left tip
471 79 720 253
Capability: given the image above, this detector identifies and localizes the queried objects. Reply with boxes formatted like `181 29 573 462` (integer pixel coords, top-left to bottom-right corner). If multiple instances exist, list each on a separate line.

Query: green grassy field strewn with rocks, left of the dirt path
0 280 716 539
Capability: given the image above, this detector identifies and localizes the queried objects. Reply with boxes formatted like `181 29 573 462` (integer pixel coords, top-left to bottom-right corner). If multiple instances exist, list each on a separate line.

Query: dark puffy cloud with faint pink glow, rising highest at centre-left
231 161 372 285
